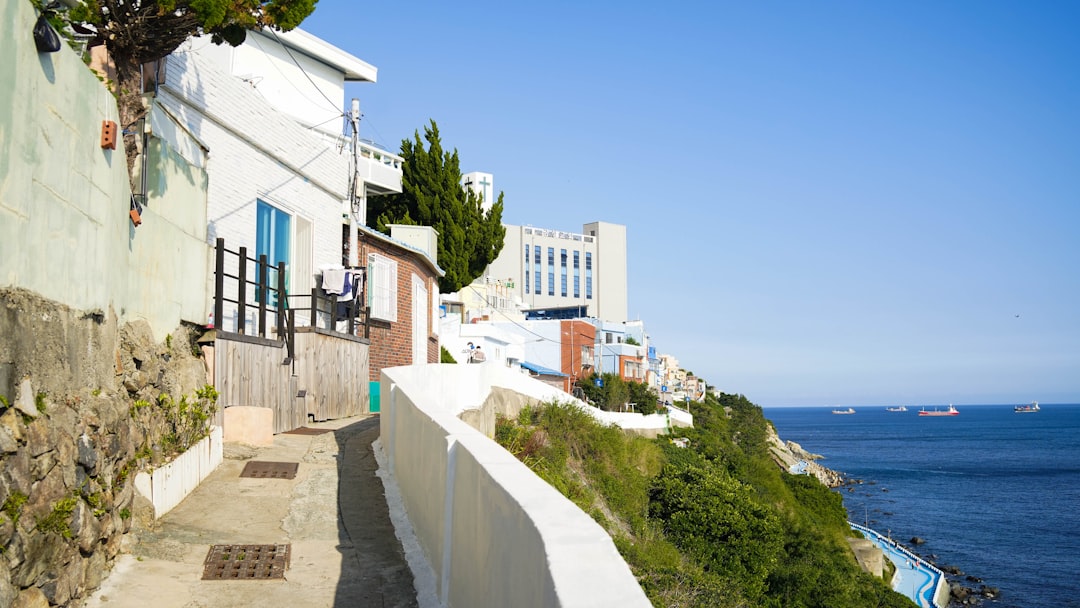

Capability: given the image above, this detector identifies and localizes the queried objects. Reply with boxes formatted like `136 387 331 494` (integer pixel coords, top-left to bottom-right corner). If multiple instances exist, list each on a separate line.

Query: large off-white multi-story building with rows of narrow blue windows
486 221 627 321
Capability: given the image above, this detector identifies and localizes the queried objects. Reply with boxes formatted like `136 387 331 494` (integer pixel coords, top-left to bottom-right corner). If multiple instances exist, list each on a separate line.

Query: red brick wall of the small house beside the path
359 234 440 380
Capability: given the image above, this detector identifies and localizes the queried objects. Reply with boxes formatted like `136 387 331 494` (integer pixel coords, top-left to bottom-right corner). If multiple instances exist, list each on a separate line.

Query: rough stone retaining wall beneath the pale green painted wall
0 289 206 606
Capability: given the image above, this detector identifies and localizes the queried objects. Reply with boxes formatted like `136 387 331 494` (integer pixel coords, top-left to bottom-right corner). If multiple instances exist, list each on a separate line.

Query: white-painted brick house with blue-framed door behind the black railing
157 31 401 330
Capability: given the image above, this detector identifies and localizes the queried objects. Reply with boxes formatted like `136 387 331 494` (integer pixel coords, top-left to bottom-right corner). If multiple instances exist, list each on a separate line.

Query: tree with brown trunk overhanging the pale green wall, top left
55 0 318 183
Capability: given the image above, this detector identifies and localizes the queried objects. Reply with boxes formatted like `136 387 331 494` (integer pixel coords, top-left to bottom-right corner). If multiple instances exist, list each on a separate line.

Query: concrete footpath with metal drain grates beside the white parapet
85 416 417 608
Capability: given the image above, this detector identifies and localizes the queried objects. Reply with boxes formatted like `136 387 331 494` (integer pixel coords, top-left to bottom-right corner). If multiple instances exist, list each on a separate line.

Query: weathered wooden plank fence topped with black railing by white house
214 239 370 433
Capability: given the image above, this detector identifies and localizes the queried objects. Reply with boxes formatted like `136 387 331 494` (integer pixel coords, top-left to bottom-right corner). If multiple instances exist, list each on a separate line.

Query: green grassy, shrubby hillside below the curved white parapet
496 395 914 608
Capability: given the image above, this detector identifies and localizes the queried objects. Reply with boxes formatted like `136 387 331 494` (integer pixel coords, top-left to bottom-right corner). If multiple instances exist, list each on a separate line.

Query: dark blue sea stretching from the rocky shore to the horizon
765 404 1080 608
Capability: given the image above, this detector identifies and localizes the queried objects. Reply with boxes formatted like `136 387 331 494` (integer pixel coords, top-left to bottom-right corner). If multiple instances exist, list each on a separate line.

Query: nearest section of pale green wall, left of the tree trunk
0 1 128 311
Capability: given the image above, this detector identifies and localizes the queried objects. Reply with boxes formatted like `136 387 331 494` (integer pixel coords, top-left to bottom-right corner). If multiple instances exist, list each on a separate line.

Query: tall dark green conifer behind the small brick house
367 120 507 294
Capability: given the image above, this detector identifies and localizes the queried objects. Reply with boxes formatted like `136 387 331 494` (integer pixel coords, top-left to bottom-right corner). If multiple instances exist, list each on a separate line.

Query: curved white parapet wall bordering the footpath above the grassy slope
380 365 650 607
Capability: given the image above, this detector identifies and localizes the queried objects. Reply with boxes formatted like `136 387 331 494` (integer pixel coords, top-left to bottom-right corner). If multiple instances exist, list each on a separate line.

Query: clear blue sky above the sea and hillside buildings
302 0 1080 406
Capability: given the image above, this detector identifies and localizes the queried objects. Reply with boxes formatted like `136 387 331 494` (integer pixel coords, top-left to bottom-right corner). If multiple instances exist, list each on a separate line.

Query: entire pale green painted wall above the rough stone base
0 0 210 339
